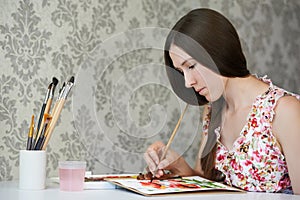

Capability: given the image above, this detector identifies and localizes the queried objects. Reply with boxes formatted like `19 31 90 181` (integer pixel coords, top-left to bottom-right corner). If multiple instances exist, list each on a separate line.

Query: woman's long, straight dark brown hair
164 8 250 180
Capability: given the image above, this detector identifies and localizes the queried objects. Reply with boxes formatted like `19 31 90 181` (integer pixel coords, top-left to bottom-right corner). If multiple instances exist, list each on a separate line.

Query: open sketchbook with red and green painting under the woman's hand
106 176 243 196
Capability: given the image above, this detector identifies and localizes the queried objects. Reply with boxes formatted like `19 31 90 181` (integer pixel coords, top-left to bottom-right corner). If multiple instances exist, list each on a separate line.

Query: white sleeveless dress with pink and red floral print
204 77 300 192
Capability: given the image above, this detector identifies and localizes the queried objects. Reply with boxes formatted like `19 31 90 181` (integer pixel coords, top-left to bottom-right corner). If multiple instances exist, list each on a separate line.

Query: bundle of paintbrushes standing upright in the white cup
26 76 74 150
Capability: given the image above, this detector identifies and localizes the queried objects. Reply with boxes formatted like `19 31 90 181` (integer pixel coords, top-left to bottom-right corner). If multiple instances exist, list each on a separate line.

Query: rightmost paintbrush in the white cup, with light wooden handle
42 76 74 150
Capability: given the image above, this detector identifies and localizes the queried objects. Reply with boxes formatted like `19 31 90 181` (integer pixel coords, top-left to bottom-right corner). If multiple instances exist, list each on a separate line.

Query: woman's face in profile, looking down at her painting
169 44 226 102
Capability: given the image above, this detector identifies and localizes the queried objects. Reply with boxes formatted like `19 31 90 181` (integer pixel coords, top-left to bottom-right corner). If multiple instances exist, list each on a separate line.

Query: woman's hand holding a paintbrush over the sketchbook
144 141 193 178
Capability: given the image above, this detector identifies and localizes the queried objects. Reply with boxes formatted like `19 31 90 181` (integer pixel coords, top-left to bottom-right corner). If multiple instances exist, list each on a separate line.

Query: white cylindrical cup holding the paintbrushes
19 150 46 190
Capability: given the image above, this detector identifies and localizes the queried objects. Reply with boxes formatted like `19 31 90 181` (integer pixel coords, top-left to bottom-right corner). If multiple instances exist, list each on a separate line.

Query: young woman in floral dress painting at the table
145 9 300 194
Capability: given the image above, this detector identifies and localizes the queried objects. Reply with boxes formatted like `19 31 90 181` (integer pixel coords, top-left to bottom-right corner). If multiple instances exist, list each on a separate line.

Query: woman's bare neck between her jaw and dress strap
223 75 269 112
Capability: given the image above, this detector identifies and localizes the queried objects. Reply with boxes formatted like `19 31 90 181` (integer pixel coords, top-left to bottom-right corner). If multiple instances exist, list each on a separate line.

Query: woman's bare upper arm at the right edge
273 96 300 194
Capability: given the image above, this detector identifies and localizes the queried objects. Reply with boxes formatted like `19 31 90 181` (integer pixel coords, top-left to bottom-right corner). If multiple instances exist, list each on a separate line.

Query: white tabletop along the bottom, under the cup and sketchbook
0 181 300 200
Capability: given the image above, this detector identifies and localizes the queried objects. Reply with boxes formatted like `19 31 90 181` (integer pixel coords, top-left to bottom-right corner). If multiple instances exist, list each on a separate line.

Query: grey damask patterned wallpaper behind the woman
0 0 300 180
